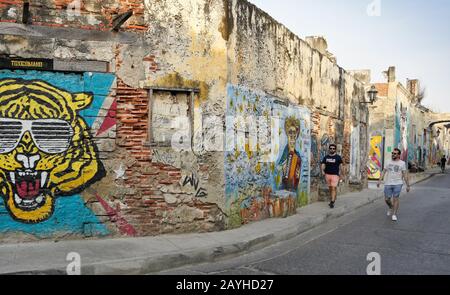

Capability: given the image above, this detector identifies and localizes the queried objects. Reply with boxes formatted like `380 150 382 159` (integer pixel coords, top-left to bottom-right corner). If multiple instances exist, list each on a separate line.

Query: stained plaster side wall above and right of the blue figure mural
225 0 367 201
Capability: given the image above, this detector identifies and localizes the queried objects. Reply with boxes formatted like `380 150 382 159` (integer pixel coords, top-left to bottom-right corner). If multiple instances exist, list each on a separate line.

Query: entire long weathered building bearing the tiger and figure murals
0 0 368 241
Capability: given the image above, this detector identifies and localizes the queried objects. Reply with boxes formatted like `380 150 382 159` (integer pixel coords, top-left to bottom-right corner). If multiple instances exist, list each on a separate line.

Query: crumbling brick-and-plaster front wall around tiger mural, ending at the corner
0 1 227 241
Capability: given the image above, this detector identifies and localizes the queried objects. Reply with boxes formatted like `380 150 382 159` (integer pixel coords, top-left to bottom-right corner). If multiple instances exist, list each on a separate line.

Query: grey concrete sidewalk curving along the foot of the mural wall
0 170 437 274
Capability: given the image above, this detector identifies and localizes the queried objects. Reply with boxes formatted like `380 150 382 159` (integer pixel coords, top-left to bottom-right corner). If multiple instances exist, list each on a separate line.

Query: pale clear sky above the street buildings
250 0 450 112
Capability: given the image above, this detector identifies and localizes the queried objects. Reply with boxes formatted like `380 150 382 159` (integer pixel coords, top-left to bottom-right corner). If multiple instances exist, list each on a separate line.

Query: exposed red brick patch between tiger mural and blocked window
116 79 222 235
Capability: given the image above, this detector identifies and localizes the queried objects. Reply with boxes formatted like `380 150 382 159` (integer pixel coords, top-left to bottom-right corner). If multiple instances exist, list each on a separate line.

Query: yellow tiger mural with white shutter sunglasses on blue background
0 70 115 237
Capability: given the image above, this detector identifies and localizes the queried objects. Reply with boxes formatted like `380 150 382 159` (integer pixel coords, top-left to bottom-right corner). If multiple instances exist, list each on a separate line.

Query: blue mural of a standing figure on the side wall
225 85 311 226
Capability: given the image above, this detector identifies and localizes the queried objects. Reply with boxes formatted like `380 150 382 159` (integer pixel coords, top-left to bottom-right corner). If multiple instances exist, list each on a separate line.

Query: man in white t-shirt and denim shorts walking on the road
377 149 411 221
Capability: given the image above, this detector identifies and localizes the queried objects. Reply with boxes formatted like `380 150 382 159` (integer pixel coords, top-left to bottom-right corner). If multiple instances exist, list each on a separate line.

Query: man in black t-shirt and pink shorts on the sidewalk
321 144 344 208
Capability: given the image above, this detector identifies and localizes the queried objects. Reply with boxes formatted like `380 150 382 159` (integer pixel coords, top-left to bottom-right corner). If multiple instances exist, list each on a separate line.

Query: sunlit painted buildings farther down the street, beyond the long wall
367 67 446 180
